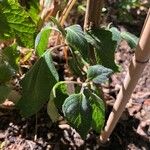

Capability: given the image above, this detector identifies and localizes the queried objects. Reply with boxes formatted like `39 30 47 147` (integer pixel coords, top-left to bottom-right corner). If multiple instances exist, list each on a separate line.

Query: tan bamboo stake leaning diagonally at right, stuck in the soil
100 9 150 143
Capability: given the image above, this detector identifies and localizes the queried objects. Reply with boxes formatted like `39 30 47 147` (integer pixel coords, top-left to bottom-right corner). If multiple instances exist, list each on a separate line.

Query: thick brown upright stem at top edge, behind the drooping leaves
84 0 104 30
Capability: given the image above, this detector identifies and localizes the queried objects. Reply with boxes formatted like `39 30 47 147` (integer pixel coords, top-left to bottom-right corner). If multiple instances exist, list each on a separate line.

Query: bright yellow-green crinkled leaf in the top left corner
0 0 36 48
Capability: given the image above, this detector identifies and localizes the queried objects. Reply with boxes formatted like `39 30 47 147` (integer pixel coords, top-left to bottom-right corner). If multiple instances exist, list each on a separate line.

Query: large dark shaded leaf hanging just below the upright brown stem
86 28 118 71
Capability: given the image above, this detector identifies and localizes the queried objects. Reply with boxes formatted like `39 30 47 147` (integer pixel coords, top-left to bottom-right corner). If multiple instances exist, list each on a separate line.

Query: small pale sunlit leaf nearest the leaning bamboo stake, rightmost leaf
121 32 139 48
